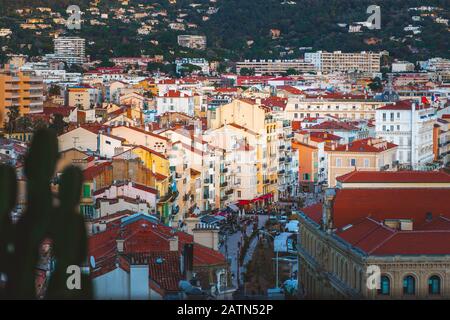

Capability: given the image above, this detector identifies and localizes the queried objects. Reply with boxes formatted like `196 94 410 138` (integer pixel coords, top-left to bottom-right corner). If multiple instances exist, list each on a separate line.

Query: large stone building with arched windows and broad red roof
298 171 450 299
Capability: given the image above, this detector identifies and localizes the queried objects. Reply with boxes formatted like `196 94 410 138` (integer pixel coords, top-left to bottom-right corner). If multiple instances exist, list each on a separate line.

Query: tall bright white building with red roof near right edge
375 100 436 169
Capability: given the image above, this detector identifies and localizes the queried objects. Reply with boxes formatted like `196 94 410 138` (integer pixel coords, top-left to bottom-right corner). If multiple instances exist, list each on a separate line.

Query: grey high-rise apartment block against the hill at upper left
49 37 86 65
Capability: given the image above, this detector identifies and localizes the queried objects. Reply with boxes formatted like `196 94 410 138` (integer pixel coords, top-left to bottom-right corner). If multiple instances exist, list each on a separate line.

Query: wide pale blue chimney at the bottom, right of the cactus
130 256 150 300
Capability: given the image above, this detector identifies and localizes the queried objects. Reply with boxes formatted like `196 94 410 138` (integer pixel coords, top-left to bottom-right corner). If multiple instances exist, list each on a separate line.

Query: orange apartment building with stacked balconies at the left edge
0 70 44 126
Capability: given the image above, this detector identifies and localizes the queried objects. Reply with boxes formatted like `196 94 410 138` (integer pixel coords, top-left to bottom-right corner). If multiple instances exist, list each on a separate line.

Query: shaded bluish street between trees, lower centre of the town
219 215 269 288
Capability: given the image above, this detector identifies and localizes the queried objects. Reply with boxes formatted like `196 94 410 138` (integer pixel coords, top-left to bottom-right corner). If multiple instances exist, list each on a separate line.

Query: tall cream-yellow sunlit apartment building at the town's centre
208 98 298 202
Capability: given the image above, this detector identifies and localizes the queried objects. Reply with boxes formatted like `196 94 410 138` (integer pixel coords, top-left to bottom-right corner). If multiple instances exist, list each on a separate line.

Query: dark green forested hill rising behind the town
0 0 450 61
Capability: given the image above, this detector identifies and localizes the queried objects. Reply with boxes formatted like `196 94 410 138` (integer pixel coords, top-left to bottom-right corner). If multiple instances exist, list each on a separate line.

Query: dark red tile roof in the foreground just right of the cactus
89 214 227 291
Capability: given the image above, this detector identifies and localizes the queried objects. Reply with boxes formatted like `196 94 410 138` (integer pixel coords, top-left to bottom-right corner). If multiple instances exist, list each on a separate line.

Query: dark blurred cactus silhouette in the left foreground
0 129 91 299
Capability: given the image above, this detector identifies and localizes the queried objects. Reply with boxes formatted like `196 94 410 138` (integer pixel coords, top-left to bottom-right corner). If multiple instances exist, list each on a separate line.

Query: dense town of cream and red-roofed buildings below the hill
0 26 450 300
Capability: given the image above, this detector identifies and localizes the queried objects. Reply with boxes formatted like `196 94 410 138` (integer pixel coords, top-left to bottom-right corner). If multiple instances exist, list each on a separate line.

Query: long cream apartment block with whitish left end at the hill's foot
305 51 381 73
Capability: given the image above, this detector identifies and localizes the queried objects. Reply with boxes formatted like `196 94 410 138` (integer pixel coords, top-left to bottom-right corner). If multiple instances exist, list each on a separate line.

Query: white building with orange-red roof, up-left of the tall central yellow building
156 90 194 117
